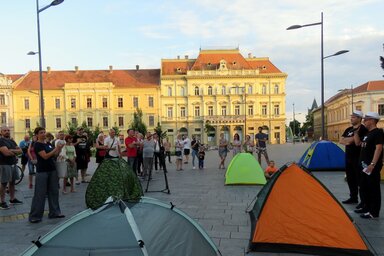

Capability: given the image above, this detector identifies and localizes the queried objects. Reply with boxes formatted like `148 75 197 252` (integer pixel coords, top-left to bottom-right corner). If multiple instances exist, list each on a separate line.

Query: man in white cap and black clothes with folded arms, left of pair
340 110 368 204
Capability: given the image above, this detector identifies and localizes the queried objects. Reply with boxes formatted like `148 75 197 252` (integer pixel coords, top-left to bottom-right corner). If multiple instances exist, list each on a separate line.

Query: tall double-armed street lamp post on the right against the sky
287 13 349 139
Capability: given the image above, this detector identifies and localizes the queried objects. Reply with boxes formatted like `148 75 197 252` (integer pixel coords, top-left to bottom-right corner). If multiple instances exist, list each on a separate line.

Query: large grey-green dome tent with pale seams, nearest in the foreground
22 197 221 256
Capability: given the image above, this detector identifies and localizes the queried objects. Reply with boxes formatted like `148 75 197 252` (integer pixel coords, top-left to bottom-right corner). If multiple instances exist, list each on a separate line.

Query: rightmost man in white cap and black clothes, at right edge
355 112 384 219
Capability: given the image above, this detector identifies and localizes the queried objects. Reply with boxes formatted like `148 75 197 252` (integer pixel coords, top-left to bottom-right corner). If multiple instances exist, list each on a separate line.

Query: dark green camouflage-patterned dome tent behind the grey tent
85 158 143 209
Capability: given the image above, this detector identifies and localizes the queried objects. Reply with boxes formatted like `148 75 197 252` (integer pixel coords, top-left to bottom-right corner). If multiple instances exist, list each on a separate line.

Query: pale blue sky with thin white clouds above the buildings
0 0 384 122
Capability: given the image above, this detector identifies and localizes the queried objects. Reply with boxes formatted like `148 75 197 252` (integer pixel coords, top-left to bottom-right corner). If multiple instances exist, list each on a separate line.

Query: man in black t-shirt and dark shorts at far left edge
0 127 23 210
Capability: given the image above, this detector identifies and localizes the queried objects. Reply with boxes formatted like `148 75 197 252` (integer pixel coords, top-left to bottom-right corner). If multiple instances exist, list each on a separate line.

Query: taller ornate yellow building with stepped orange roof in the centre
161 49 287 144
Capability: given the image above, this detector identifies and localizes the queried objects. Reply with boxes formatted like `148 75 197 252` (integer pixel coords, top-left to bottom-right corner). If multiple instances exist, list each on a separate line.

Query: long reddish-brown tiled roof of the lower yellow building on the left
14 67 160 90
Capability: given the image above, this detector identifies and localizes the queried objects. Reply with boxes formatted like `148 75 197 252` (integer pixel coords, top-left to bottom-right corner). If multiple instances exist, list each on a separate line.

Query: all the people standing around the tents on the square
0 116 384 223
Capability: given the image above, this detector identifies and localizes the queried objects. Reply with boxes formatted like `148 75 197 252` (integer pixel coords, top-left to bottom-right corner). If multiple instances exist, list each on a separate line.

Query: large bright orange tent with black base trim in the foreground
249 164 373 256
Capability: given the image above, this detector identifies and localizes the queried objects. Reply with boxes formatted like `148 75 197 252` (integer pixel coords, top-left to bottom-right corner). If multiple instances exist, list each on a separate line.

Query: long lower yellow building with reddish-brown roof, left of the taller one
13 66 160 141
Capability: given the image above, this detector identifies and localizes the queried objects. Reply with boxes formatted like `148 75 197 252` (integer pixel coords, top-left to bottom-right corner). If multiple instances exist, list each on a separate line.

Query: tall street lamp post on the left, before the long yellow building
28 0 64 128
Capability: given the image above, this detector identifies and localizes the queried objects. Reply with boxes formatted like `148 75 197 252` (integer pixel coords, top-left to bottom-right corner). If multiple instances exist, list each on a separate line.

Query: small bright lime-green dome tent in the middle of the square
225 153 267 185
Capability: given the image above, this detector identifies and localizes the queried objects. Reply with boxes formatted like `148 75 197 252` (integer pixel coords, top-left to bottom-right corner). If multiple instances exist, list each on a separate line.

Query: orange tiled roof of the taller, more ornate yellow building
161 49 282 75
